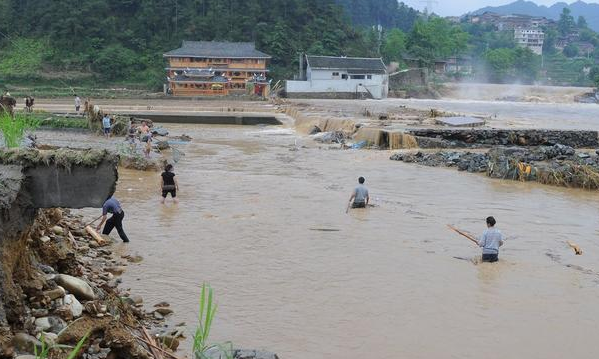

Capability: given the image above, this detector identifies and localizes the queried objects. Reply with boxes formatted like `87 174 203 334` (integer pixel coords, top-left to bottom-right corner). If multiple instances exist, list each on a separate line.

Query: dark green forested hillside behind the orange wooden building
0 0 404 85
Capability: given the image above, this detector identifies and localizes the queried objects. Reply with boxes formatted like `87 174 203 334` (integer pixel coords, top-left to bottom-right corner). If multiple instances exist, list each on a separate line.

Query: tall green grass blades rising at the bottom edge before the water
192 284 233 359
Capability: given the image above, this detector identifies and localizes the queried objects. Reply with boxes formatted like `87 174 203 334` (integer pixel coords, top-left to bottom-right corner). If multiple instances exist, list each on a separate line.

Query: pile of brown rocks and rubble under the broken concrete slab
0 209 183 359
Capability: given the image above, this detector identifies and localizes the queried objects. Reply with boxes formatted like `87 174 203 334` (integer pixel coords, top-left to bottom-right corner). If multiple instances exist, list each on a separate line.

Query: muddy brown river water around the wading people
42 116 599 359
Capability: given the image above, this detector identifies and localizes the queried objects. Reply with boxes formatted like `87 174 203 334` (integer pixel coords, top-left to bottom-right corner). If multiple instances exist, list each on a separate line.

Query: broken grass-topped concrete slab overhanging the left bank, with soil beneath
0 149 118 332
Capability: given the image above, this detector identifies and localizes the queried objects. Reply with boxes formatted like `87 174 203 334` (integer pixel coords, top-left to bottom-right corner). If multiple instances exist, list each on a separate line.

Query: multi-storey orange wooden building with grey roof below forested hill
164 41 270 96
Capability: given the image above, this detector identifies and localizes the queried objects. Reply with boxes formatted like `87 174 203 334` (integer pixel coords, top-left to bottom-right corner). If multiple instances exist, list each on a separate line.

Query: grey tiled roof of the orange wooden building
164 41 270 59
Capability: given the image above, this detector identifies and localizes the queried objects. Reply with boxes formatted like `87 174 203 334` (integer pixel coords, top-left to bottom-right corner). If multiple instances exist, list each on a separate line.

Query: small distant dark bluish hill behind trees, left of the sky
336 0 418 32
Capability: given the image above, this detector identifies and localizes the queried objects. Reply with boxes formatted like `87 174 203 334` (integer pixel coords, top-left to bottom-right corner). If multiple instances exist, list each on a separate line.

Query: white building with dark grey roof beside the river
285 55 389 99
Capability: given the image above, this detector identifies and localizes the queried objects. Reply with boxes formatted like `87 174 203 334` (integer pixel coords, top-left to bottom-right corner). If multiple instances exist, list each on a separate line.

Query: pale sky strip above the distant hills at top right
400 0 599 16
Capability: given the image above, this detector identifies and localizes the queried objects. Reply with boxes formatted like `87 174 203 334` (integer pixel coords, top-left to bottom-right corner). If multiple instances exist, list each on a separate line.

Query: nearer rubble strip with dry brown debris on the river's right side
391 144 599 190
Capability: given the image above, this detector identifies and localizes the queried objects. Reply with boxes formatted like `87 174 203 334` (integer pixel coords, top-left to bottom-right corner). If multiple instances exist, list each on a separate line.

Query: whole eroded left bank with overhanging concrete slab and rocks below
0 150 178 359
